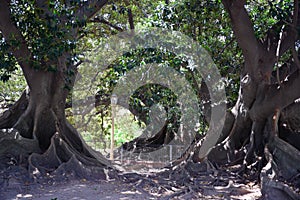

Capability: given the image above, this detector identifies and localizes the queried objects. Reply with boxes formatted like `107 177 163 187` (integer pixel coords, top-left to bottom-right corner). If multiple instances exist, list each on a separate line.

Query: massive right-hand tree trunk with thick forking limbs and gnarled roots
193 0 300 199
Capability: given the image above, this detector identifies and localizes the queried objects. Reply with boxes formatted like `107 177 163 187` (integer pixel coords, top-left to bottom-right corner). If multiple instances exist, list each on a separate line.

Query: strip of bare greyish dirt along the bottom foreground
0 180 260 200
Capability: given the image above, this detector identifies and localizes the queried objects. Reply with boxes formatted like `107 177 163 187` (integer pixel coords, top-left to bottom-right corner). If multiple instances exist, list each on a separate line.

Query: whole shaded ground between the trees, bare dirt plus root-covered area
0 164 261 200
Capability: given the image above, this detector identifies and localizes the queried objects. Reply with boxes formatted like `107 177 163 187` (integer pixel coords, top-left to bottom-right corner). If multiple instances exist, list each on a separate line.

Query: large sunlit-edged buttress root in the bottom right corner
261 137 300 200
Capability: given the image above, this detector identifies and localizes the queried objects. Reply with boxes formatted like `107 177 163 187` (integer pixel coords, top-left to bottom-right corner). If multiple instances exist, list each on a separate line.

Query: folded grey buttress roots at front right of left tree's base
28 134 108 179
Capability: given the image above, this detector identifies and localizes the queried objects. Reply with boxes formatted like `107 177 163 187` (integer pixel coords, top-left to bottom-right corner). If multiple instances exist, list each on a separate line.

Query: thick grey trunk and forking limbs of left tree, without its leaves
0 0 110 182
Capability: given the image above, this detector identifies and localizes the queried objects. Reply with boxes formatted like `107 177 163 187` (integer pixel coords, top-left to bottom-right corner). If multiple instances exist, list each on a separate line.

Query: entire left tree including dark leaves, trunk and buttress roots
0 0 109 176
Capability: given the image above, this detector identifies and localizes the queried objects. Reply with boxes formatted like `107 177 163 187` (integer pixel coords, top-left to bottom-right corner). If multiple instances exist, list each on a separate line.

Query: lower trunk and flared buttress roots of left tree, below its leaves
0 67 110 181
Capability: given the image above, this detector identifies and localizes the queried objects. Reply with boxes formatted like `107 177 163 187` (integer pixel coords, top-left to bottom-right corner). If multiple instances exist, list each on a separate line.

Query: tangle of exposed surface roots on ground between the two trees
120 161 260 199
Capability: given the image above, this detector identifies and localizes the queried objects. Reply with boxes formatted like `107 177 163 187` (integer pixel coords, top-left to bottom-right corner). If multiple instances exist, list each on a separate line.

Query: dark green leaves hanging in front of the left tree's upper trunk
0 0 85 77
